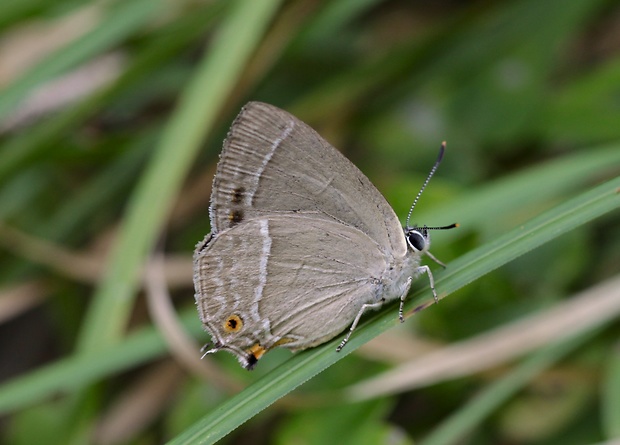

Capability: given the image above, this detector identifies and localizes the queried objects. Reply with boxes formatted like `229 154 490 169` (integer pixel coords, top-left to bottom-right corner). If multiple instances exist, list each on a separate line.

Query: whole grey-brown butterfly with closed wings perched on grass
194 102 455 370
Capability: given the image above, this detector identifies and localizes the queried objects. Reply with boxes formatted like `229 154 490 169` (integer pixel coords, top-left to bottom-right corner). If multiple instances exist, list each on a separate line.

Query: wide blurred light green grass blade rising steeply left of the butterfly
78 0 280 352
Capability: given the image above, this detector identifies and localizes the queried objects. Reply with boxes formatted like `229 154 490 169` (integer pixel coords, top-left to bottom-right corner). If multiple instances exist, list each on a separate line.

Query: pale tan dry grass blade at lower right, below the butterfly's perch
345 277 620 400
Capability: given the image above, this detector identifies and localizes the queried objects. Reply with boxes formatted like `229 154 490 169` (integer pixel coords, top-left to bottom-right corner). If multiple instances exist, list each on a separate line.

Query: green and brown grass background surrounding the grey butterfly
0 0 620 445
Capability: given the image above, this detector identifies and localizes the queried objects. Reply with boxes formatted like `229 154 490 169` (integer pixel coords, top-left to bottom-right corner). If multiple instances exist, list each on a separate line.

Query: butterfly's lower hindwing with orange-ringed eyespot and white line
194 215 388 368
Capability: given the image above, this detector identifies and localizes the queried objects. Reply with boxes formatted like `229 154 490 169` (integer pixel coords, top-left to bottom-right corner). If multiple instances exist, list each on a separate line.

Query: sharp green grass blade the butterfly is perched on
165 178 620 445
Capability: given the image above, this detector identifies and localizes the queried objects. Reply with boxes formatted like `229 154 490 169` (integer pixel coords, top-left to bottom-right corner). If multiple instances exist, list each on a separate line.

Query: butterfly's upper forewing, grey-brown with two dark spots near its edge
210 102 407 255
